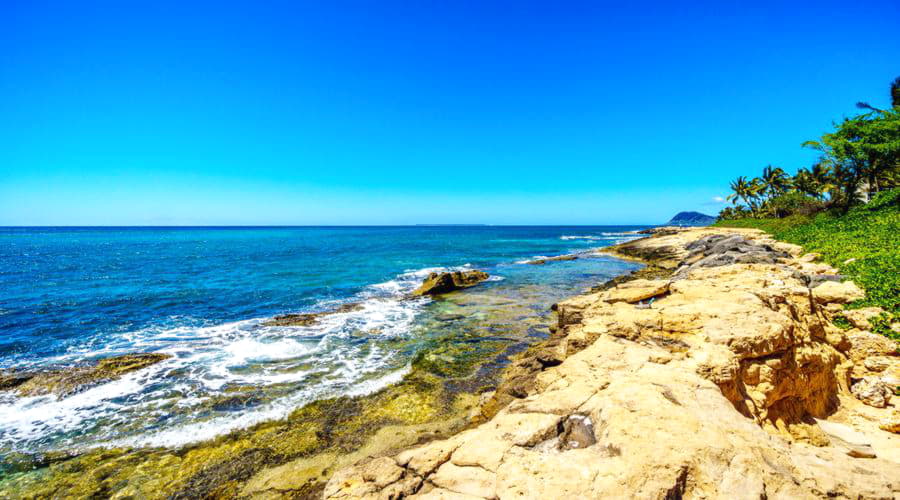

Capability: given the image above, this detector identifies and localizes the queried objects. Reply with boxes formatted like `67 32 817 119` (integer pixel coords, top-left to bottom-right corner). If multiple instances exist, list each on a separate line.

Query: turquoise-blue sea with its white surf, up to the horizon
0 226 638 453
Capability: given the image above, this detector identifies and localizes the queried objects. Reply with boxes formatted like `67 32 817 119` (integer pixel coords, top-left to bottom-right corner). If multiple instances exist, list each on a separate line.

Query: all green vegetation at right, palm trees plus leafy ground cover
716 78 900 340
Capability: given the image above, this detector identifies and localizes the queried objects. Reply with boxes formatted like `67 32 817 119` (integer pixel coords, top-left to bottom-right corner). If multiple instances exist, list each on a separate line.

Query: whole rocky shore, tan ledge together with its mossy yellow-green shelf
7 228 900 498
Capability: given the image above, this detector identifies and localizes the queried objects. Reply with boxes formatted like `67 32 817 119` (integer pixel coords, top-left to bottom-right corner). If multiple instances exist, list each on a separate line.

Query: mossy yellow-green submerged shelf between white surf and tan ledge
0 241 633 498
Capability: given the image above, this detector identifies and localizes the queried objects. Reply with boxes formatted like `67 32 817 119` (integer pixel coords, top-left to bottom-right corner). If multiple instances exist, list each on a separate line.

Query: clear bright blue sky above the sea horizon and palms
0 0 900 225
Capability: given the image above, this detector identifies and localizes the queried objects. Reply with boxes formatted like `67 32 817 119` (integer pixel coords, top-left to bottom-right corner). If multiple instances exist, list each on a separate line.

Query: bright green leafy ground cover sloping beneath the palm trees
716 188 900 341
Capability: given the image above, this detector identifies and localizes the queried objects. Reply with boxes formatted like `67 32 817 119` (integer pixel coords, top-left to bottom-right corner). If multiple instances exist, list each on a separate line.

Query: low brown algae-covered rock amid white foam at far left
9 353 172 398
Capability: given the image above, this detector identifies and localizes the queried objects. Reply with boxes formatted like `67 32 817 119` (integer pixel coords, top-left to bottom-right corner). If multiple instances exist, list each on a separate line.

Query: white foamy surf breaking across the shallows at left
0 266 469 452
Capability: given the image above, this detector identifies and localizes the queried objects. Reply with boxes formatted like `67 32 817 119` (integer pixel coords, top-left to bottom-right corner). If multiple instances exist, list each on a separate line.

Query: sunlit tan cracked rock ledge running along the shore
324 228 900 499
